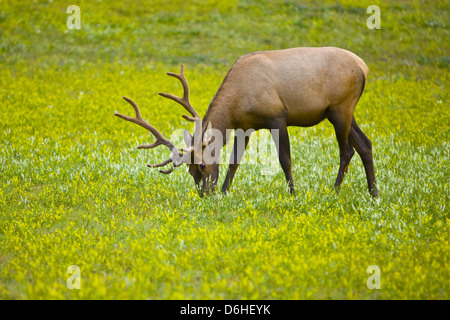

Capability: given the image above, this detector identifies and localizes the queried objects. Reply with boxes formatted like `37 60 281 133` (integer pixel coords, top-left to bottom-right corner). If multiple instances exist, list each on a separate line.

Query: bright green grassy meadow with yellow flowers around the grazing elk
0 0 450 299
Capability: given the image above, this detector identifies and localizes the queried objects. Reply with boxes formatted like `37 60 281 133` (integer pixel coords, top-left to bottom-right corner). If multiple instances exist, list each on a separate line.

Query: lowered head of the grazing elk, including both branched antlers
114 65 219 197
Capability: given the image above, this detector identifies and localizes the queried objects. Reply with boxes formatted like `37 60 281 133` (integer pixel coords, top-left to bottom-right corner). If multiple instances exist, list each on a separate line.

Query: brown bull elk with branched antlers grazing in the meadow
115 47 378 197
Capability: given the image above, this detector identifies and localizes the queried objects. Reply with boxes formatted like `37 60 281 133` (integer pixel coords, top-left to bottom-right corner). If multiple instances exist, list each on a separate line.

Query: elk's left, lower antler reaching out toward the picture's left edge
114 97 187 174
